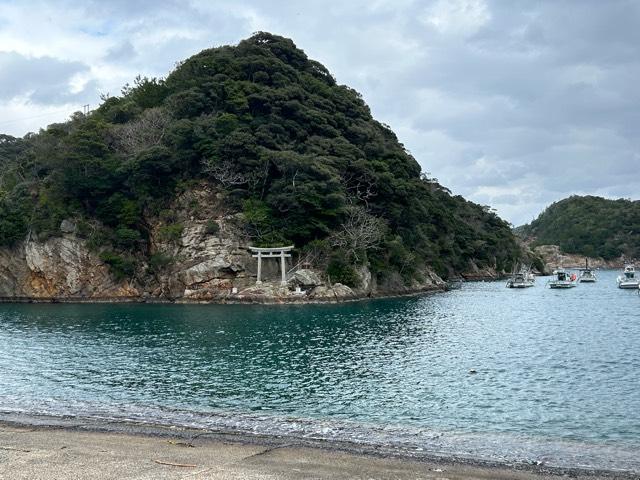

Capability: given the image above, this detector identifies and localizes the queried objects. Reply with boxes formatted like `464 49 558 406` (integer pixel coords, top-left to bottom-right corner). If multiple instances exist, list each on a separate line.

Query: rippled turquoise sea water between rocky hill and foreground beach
0 272 640 471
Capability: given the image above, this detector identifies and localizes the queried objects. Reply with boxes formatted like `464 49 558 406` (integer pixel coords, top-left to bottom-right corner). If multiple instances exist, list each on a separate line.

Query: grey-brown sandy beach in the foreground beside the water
0 415 638 480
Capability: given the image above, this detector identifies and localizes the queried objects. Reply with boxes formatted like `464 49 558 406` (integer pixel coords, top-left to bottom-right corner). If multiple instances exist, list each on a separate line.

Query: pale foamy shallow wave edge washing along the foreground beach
0 410 640 475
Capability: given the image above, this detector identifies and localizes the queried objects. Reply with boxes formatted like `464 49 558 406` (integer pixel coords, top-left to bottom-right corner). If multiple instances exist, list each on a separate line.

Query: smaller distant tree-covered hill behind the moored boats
517 196 640 260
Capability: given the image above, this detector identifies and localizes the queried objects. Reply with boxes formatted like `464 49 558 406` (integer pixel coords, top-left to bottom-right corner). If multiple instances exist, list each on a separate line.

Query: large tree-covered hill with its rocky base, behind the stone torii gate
0 32 526 302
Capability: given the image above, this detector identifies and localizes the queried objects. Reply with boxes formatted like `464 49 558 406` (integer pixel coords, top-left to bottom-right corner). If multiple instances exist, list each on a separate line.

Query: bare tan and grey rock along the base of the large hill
0 188 444 302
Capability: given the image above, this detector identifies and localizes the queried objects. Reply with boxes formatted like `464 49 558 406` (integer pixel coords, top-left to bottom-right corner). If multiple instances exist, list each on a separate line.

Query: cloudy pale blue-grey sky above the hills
0 0 640 225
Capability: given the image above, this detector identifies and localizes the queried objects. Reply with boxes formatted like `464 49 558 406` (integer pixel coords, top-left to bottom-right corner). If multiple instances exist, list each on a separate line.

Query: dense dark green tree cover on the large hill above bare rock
0 33 520 284
